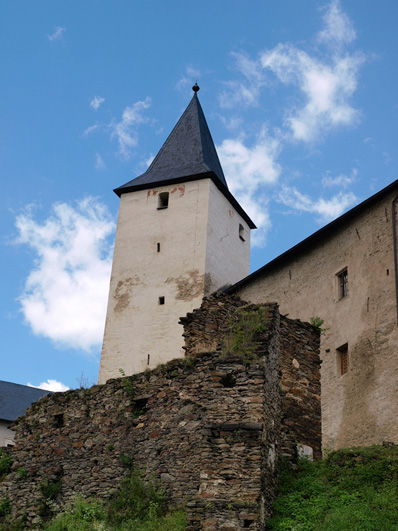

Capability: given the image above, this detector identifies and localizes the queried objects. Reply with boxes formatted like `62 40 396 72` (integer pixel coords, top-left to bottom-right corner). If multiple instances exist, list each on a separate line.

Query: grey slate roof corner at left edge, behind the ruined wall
0 380 51 421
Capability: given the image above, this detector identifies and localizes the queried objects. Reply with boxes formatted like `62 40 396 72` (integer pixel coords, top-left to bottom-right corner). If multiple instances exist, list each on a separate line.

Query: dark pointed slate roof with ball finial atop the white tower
114 85 256 229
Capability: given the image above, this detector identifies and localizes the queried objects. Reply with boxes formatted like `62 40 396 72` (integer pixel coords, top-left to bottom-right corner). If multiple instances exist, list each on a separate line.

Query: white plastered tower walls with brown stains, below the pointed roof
99 179 250 383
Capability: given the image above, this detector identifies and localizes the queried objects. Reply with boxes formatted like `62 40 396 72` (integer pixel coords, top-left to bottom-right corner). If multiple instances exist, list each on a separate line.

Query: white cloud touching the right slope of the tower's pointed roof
217 129 281 246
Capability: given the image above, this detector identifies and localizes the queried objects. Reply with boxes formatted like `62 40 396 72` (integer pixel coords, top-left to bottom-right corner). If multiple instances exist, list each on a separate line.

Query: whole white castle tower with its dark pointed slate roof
99 84 255 383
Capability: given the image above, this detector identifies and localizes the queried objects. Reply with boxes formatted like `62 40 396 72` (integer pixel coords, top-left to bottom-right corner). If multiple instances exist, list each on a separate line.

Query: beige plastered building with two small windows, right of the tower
230 181 398 449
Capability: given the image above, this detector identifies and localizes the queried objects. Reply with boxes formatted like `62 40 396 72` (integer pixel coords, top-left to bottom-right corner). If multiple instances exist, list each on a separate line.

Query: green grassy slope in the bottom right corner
267 446 398 531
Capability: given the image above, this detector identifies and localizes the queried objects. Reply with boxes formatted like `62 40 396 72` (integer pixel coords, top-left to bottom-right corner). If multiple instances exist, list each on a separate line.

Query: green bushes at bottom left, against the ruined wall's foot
40 466 186 531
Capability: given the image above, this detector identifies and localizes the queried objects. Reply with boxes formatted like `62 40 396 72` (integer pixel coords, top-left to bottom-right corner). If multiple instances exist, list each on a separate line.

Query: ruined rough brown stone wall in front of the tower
0 297 320 531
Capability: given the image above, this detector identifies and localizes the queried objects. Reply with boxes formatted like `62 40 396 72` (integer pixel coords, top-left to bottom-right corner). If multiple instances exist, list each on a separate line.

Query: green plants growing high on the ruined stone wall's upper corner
221 305 269 363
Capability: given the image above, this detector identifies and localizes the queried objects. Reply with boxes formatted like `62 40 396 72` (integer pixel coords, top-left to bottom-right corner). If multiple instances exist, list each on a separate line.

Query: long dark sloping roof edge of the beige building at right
225 180 398 293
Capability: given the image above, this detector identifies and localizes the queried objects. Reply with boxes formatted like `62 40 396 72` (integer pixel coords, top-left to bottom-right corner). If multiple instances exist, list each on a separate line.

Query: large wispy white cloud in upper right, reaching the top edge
220 0 365 142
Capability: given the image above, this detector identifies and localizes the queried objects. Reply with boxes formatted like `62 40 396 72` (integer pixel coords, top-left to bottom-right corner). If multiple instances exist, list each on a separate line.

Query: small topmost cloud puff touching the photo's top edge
318 0 357 46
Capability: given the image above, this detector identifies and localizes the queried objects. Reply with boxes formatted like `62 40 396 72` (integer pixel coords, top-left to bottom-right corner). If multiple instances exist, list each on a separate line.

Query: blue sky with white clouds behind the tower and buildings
0 0 398 389
